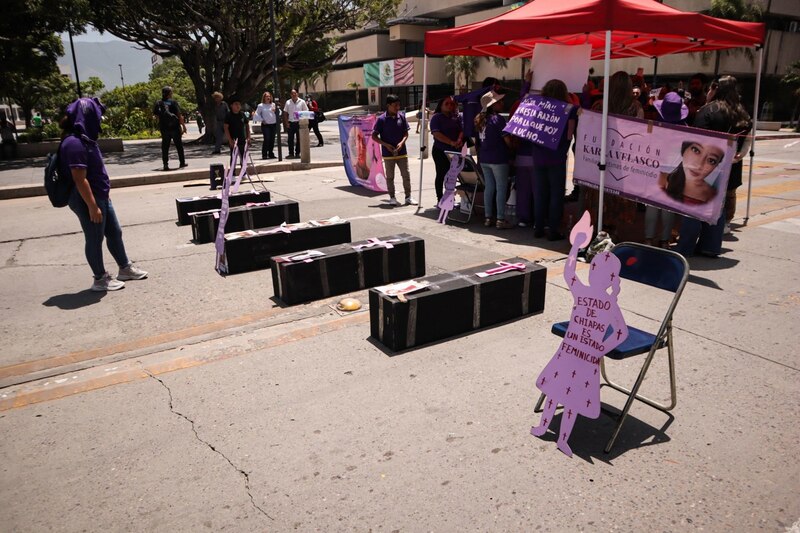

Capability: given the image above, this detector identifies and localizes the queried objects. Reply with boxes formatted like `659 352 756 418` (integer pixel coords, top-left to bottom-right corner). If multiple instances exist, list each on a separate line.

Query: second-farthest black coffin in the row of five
191 200 300 244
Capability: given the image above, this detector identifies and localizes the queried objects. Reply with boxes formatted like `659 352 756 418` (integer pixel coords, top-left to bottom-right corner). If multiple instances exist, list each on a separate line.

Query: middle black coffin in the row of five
220 220 351 274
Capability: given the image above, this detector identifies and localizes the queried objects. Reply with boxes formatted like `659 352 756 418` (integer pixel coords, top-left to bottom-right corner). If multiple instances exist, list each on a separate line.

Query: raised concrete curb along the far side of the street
0 161 344 200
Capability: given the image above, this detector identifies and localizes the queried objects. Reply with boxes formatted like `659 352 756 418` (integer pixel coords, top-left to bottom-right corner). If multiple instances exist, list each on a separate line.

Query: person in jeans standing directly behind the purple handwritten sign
532 80 578 241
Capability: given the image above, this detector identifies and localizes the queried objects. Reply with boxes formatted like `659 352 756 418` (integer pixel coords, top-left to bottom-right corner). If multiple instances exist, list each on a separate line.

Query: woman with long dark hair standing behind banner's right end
677 76 752 257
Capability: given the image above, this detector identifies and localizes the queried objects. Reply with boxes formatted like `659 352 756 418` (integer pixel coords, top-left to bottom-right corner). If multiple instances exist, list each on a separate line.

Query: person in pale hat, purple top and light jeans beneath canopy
475 91 513 229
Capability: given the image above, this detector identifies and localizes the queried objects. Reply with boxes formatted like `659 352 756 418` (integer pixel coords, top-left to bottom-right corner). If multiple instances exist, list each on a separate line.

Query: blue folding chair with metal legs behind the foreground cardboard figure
535 242 689 453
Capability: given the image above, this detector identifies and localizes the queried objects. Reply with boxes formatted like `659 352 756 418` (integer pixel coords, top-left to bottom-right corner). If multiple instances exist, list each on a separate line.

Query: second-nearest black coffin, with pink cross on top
270 233 425 305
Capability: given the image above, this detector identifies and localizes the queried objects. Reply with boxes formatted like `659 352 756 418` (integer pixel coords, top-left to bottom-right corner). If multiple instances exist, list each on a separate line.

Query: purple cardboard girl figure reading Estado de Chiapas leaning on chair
531 211 628 457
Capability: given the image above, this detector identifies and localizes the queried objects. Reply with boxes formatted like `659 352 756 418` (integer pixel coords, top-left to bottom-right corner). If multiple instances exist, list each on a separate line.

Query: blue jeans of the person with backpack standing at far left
69 187 131 279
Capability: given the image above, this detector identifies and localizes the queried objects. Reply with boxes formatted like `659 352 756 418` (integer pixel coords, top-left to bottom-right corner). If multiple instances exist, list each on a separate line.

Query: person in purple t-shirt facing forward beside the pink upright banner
372 94 417 206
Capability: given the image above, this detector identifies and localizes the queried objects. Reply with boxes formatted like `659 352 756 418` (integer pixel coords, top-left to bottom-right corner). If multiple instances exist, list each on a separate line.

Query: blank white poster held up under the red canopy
531 44 592 93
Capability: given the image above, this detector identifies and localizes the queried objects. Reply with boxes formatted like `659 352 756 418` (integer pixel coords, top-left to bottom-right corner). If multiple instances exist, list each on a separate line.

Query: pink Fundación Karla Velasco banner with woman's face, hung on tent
574 110 736 224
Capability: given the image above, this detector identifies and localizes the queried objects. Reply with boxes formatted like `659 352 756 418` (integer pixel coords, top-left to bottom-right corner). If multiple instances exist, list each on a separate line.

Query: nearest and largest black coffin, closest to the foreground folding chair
369 257 547 351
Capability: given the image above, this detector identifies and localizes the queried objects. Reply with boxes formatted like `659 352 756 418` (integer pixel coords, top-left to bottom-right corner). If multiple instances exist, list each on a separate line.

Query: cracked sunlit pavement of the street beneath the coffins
0 140 800 532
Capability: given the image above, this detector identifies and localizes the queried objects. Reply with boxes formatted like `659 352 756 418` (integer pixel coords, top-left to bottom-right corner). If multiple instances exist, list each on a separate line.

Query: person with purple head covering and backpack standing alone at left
58 98 147 292
